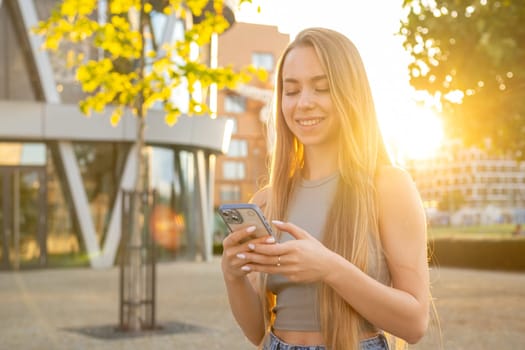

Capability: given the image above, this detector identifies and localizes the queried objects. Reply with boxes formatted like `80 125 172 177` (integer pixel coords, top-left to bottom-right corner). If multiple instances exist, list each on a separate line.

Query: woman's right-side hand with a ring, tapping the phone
235 221 335 283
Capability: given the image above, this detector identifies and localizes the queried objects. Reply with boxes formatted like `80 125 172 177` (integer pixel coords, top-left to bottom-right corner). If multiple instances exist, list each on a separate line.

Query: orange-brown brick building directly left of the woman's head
215 22 290 207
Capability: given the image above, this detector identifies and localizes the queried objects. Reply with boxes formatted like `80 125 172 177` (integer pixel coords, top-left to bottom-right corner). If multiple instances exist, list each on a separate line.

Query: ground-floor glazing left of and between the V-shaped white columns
0 142 124 268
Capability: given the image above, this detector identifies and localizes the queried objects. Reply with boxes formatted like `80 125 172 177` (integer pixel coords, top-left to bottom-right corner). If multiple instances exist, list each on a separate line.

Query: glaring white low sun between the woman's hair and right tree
380 104 444 162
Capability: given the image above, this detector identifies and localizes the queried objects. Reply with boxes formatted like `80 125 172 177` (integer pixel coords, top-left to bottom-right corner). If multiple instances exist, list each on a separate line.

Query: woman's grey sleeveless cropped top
267 173 390 332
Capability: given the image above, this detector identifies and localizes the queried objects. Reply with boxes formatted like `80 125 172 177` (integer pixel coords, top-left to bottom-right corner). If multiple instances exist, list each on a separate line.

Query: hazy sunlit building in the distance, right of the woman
406 141 525 225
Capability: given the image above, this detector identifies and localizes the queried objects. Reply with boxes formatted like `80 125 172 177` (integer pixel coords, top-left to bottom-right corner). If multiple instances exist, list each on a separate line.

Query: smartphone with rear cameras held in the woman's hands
219 203 273 237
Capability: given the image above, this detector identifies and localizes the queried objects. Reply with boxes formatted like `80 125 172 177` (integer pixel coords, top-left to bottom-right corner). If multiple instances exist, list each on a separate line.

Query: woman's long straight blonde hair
263 28 391 350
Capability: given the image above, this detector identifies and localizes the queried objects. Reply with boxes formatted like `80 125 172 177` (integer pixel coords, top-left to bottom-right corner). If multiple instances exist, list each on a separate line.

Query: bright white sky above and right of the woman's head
236 0 442 158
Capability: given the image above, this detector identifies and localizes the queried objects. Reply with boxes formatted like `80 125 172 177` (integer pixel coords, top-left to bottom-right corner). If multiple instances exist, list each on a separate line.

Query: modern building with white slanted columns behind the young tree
0 0 231 269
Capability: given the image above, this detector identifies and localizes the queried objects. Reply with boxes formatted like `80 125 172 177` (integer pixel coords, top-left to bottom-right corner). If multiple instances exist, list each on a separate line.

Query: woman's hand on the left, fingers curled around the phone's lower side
221 226 275 279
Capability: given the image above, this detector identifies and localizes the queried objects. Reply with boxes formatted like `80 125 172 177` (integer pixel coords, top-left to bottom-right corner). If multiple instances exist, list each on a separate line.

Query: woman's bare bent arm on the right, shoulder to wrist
324 167 430 344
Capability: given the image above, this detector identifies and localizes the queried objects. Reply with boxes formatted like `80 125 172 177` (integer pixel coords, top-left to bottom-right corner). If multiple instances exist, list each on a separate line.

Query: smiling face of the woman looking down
281 46 339 148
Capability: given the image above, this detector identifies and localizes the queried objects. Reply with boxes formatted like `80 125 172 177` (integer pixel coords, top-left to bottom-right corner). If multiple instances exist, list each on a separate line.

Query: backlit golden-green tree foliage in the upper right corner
399 0 525 158
